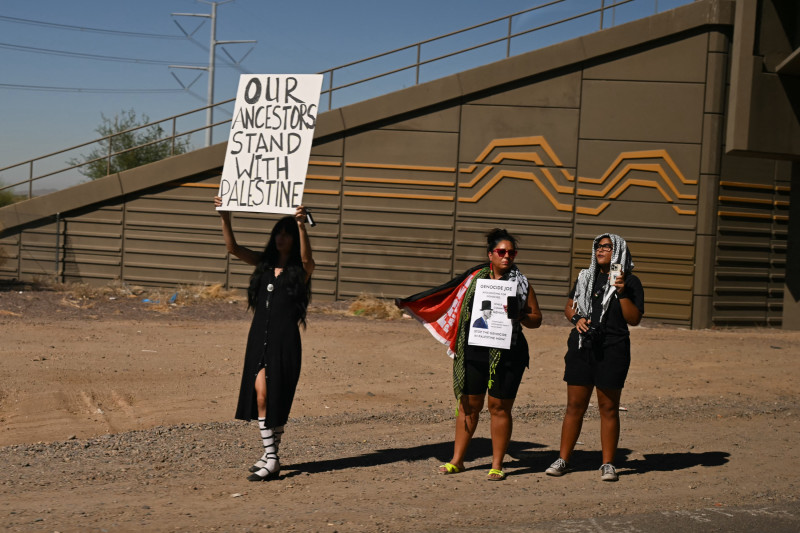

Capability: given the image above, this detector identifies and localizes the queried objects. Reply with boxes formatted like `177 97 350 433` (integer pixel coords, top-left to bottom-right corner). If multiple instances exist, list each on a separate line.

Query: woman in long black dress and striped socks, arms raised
214 196 314 481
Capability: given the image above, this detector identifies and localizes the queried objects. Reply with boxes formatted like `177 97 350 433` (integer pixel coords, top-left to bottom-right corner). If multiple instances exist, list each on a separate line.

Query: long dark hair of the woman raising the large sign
247 216 311 326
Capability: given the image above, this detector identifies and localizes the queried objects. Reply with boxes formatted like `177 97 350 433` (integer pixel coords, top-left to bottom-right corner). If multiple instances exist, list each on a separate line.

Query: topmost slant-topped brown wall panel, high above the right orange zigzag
583 33 708 83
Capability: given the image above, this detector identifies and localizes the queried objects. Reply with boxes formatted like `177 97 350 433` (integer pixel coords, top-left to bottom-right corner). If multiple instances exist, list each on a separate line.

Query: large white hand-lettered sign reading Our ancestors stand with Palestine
217 74 322 214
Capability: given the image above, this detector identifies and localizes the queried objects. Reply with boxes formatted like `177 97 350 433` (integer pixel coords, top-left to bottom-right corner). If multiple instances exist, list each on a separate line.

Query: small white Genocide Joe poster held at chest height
467 279 517 350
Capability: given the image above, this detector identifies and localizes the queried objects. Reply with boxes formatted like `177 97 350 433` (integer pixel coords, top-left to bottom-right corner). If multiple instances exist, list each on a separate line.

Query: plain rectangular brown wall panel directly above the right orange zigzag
580 80 705 143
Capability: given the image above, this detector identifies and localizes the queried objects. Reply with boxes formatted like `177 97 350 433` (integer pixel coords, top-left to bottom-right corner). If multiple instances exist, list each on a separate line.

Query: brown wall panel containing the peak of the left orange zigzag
459 105 579 167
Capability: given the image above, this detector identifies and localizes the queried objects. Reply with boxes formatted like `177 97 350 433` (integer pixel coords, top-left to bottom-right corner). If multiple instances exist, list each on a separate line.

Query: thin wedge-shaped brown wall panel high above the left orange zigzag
469 72 581 107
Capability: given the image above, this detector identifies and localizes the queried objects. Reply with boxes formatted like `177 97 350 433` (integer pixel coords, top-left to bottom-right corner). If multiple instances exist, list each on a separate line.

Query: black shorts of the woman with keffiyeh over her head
564 329 631 389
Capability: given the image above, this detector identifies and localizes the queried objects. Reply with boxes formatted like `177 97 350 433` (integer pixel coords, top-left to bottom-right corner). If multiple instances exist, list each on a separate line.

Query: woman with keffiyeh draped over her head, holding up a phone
546 233 644 481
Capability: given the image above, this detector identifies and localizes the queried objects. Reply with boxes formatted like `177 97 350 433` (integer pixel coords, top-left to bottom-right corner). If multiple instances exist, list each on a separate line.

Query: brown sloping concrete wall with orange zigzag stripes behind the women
0 0 791 327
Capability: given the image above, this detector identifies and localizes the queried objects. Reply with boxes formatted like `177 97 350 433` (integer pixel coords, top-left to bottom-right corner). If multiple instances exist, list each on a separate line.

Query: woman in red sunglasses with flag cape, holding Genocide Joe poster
396 228 542 481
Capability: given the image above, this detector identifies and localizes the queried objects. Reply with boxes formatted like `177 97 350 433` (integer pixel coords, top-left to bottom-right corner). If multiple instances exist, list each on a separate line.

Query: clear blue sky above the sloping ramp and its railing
0 0 691 188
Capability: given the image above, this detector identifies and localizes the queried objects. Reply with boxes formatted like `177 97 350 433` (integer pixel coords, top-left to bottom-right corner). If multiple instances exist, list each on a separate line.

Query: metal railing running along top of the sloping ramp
0 0 693 202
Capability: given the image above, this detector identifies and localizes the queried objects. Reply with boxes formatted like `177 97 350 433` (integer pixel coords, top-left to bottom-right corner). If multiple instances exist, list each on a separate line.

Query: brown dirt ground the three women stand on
0 290 800 532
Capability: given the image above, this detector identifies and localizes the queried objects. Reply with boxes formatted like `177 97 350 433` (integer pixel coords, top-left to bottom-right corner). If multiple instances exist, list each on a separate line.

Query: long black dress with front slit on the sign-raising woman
236 269 302 427
